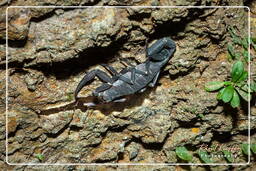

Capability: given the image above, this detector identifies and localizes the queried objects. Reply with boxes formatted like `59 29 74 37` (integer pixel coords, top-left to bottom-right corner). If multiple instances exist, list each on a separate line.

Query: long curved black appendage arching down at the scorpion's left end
75 69 113 99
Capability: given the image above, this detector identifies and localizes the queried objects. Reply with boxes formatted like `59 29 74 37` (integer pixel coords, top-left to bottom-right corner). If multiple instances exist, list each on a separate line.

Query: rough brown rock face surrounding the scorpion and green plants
0 0 256 170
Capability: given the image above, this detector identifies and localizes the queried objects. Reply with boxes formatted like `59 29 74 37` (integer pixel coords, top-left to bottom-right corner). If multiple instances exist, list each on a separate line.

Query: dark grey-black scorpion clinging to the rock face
74 37 176 106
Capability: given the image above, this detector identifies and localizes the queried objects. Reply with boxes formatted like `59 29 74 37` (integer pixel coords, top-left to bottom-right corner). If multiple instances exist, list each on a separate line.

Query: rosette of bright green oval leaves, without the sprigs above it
205 61 254 108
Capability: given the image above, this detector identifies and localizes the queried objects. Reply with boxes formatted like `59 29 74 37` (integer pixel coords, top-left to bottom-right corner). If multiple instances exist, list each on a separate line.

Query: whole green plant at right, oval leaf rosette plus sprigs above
205 27 256 108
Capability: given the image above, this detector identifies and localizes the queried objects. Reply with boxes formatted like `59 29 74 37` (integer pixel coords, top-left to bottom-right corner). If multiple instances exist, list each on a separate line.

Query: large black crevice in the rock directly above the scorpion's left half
29 37 128 79
